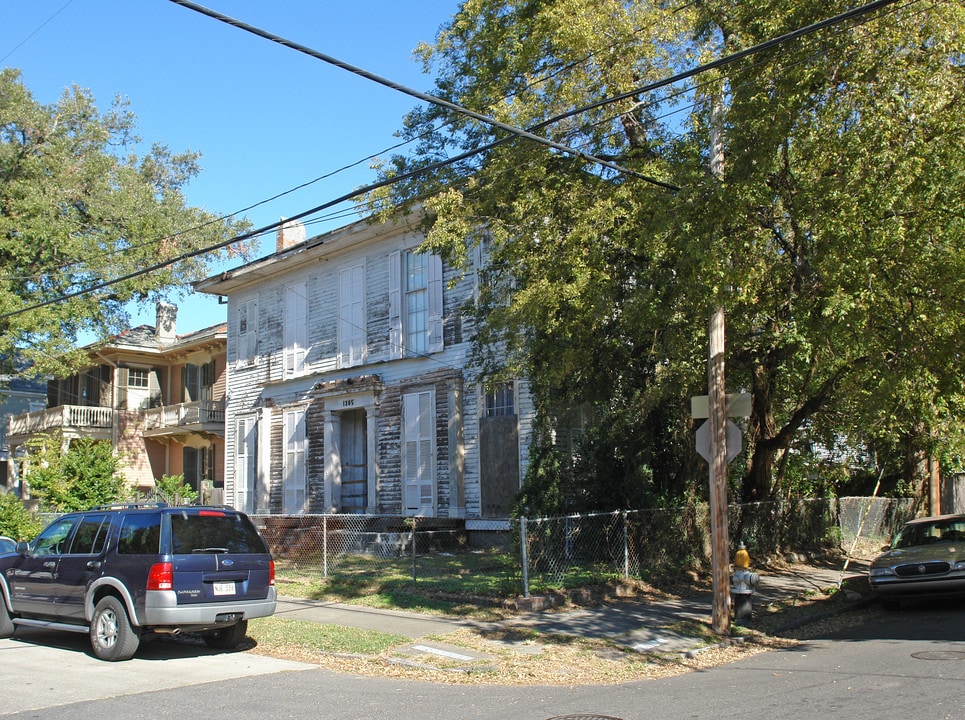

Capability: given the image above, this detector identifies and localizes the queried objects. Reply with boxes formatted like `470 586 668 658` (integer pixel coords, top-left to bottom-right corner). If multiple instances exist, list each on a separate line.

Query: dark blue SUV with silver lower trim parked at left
0 505 276 661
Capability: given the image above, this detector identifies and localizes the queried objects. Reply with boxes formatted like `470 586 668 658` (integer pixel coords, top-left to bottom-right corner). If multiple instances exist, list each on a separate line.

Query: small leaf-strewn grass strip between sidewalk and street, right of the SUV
248 617 408 655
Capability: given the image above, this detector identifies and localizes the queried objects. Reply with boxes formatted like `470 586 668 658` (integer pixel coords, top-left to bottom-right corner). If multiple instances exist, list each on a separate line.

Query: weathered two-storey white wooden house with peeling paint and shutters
195 218 532 529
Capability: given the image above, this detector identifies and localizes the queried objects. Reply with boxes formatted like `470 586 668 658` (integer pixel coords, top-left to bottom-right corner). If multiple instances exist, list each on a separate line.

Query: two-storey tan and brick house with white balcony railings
7 303 227 503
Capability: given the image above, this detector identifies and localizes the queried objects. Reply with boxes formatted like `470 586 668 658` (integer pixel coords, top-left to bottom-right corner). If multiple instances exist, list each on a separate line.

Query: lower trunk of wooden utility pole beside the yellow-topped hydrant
707 307 730 635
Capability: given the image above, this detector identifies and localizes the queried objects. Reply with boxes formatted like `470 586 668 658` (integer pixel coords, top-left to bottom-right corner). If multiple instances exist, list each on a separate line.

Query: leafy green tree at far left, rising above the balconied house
0 69 247 372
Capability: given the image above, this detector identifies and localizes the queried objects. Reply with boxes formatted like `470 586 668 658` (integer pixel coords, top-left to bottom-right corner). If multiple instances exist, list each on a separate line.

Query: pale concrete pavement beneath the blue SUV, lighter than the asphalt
0 627 314 715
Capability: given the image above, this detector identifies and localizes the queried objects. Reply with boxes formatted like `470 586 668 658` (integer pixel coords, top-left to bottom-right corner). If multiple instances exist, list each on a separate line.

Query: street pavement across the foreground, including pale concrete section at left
0 603 965 720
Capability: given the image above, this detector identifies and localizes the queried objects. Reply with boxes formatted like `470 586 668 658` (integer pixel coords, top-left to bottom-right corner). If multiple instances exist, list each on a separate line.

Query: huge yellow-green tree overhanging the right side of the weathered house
367 0 965 506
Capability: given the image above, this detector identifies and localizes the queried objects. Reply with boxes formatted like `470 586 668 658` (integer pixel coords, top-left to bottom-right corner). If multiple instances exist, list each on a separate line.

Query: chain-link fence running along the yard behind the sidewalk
253 498 915 598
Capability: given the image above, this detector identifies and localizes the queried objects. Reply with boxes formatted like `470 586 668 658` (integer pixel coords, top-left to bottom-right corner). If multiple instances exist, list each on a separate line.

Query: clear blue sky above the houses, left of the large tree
0 0 458 333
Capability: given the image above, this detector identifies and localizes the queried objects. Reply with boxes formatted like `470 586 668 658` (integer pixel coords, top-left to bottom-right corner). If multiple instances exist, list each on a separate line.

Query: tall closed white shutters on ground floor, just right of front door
402 391 435 515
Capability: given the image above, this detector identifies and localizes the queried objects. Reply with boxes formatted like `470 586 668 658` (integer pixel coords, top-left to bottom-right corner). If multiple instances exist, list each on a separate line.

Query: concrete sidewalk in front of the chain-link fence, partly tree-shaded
275 561 867 652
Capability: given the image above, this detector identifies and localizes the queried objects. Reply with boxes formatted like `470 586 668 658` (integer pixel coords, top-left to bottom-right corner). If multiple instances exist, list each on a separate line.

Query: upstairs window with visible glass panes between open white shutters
389 250 444 359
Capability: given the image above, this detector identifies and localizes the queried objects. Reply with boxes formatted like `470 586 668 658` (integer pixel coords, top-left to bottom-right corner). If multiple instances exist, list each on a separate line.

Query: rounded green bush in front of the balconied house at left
23 435 127 512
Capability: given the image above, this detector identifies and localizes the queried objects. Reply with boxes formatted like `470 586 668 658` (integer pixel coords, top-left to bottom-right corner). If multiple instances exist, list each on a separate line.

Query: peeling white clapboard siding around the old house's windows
206 211 531 518
